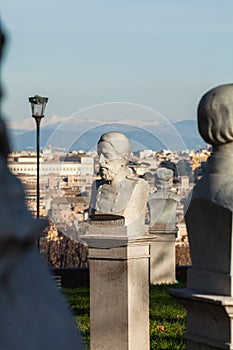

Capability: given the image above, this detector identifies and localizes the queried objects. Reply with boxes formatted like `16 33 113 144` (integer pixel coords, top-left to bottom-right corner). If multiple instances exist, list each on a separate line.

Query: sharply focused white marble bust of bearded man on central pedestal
90 131 148 225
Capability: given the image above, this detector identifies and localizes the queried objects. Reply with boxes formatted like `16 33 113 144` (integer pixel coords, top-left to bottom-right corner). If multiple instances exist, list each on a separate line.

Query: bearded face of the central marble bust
98 141 126 181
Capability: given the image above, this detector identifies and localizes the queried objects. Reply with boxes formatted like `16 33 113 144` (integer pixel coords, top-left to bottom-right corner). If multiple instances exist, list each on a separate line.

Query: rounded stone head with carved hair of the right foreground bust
198 84 233 146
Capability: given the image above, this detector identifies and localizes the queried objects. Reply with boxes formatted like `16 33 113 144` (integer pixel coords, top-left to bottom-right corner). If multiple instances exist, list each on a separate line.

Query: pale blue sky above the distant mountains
0 0 233 121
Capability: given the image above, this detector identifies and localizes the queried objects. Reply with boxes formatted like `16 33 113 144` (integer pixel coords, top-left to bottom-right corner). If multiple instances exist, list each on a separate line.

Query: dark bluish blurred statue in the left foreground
0 20 83 350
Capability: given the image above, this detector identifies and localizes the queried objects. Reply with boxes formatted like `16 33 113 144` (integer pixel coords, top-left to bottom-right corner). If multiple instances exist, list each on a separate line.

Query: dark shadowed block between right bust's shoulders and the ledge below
185 200 233 297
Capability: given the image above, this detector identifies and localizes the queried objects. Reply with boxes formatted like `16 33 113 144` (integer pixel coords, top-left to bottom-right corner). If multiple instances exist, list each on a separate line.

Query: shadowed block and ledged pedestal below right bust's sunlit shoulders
169 198 233 350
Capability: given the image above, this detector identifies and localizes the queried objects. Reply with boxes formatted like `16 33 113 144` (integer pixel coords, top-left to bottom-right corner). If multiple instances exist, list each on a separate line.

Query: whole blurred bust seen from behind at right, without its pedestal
185 84 233 296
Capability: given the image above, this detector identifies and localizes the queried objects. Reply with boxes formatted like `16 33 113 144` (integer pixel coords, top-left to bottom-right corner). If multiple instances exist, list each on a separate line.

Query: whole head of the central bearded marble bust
98 131 131 181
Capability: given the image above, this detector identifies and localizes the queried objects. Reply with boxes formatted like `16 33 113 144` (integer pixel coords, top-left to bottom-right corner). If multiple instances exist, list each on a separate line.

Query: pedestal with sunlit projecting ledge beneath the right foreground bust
169 289 233 350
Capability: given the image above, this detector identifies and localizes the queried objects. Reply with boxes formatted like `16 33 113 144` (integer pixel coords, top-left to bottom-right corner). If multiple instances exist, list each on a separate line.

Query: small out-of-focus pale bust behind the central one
149 167 180 231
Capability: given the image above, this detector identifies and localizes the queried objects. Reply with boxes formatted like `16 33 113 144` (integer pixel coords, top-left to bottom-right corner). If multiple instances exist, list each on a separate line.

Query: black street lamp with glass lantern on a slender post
29 95 48 219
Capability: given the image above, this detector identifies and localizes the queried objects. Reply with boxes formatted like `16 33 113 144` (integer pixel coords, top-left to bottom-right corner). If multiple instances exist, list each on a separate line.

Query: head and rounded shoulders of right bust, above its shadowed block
193 84 233 204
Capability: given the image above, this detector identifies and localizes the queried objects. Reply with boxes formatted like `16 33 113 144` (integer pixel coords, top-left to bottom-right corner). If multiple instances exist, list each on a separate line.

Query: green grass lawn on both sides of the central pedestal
64 284 186 350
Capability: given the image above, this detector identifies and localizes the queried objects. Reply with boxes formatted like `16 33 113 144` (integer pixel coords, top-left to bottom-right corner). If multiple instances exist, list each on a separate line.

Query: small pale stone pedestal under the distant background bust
149 229 177 284
